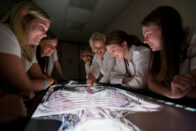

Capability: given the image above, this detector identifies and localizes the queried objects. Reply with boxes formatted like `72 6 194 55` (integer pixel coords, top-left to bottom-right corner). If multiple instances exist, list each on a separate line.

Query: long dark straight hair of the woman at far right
142 6 185 81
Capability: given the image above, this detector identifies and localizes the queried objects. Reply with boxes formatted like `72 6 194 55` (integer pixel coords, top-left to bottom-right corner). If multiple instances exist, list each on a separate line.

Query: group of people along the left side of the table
0 1 66 123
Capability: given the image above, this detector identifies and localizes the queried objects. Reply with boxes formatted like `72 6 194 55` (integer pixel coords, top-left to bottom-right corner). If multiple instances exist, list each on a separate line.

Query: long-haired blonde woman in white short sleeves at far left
0 1 53 92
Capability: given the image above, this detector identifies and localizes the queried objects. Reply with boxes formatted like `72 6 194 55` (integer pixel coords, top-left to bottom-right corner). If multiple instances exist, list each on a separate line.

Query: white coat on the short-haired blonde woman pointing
89 51 116 83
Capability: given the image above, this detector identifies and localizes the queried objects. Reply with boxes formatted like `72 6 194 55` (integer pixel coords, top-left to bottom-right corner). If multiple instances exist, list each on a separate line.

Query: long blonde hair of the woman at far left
1 1 51 61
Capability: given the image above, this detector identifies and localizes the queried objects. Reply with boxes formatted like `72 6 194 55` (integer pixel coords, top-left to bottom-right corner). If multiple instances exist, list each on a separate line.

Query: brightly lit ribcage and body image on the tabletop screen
32 82 161 131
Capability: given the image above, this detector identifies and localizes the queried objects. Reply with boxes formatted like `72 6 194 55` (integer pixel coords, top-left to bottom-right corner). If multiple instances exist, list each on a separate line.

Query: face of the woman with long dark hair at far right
142 26 163 51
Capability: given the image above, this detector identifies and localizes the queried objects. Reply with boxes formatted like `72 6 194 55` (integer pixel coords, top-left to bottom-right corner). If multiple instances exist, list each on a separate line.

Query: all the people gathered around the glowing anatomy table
0 1 196 123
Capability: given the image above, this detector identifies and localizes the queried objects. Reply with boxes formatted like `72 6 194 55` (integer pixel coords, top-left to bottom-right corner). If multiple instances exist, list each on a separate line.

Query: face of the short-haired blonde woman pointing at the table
93 40 106 58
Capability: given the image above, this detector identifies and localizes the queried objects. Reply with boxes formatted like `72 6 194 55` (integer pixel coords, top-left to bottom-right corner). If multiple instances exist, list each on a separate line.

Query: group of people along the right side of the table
82 6 196 98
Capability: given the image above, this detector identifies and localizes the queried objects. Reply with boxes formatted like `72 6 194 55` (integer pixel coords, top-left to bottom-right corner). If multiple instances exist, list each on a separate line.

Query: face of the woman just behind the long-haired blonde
41 39 57 56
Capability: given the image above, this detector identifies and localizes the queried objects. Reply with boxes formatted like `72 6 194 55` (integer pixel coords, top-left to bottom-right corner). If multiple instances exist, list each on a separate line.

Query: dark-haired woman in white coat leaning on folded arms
106 30 150 89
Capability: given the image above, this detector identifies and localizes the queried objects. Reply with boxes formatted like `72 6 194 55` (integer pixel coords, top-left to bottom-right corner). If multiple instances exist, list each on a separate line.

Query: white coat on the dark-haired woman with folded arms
110 45 150 89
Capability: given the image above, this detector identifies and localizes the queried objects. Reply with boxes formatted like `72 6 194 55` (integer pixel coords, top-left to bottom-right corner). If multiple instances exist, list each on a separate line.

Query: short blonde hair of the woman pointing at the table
89 32 106 52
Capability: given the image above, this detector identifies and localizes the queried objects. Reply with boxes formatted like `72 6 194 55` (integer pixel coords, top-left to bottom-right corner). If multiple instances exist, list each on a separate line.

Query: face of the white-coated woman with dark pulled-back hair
106 44 125 60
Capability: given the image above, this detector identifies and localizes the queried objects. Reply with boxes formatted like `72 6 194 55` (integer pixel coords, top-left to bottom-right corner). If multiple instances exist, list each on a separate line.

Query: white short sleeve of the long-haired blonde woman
0 23 21 58
